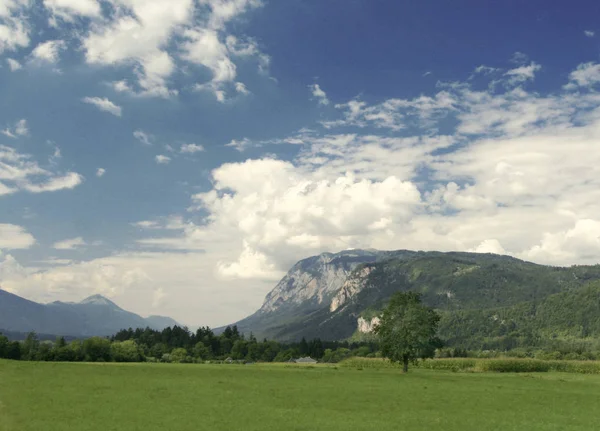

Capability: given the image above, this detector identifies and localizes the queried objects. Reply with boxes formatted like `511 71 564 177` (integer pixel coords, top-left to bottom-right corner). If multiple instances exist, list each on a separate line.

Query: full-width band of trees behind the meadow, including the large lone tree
0 292 600 370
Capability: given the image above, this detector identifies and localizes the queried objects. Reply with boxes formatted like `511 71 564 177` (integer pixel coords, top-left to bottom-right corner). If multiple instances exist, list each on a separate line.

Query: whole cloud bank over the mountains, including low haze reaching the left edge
5 56 600 324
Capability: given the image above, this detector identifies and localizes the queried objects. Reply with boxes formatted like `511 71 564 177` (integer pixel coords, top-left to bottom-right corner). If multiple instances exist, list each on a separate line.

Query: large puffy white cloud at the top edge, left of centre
71 0 269 100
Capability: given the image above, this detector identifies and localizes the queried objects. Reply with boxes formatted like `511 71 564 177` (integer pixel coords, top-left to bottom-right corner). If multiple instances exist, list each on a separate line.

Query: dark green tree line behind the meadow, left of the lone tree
0 326 378 363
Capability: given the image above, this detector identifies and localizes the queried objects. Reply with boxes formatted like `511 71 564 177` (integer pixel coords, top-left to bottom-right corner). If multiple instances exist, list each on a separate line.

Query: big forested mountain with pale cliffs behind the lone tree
232 250 600 347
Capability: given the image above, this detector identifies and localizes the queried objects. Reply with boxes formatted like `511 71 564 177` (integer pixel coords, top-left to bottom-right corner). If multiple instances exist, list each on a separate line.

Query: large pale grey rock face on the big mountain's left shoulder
259 250 378 314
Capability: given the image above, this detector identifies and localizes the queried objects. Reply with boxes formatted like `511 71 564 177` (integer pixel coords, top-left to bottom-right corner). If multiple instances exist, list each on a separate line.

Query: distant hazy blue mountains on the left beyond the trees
0 289 177 337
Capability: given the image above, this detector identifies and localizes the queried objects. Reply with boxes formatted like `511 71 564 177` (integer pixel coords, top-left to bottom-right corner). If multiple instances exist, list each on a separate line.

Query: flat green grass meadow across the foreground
0 361 600 431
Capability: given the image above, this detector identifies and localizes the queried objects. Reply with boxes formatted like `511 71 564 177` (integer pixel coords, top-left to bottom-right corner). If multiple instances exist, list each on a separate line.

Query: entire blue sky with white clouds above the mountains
0 0 600 327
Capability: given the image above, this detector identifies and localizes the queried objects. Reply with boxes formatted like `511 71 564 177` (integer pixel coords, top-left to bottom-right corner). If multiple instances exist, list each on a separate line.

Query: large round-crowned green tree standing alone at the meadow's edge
375 292 441 372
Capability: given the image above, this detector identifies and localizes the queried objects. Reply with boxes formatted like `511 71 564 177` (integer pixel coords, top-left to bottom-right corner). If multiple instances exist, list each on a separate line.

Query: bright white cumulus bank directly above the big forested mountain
141 60 600 286
